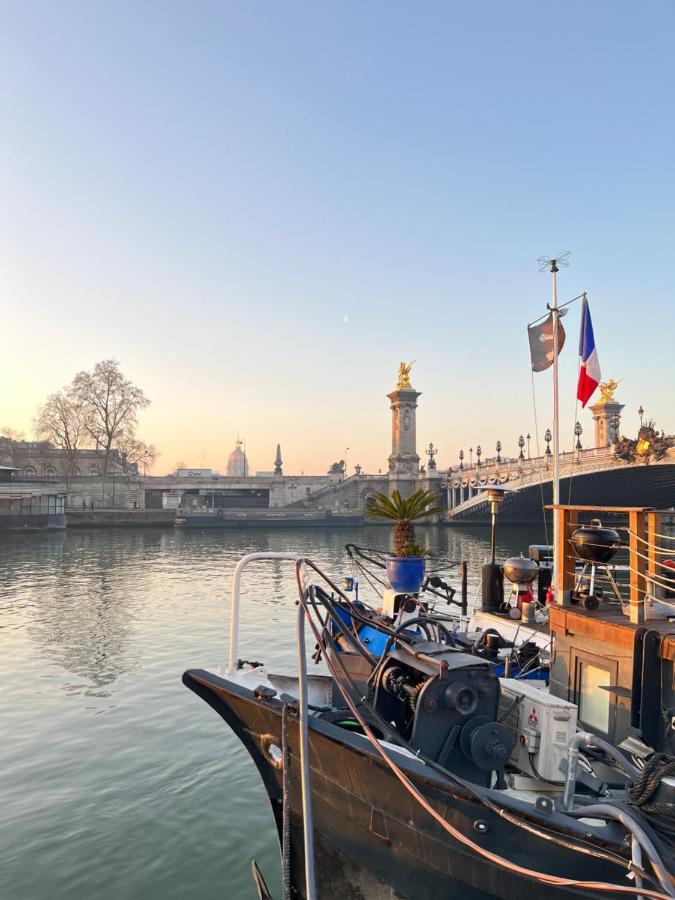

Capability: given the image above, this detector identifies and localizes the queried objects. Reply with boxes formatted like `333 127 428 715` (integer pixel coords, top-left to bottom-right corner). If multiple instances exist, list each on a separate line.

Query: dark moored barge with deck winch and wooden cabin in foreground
184 524 675 898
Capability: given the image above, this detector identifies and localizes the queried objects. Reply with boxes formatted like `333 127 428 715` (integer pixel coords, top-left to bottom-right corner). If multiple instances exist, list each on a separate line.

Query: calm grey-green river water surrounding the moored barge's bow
0 528 544 900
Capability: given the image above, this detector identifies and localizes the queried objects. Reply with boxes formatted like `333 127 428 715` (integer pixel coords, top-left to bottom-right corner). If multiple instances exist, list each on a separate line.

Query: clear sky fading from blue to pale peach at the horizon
0 0 675 474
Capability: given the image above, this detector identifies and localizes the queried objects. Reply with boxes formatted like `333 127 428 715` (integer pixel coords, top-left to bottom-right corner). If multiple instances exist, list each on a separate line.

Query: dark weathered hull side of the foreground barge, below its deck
183 670 644 900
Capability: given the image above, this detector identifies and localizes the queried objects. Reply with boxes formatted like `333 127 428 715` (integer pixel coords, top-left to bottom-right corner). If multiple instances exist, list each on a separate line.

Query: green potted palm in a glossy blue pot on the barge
366 490 443 594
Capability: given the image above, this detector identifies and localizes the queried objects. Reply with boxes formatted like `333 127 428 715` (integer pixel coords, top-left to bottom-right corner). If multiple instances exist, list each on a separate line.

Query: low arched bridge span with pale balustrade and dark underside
446 446 675 525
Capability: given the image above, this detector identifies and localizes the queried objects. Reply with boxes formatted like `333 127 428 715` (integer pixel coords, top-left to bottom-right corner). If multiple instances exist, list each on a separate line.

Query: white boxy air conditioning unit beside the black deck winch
499 678 577 782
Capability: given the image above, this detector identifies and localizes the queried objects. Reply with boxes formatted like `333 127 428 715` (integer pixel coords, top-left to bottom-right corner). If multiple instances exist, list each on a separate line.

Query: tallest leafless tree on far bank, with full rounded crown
72 359 150 475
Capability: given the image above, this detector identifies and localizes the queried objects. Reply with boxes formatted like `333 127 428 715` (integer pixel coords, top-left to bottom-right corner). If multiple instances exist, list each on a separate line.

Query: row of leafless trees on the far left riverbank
2 359 158 475
